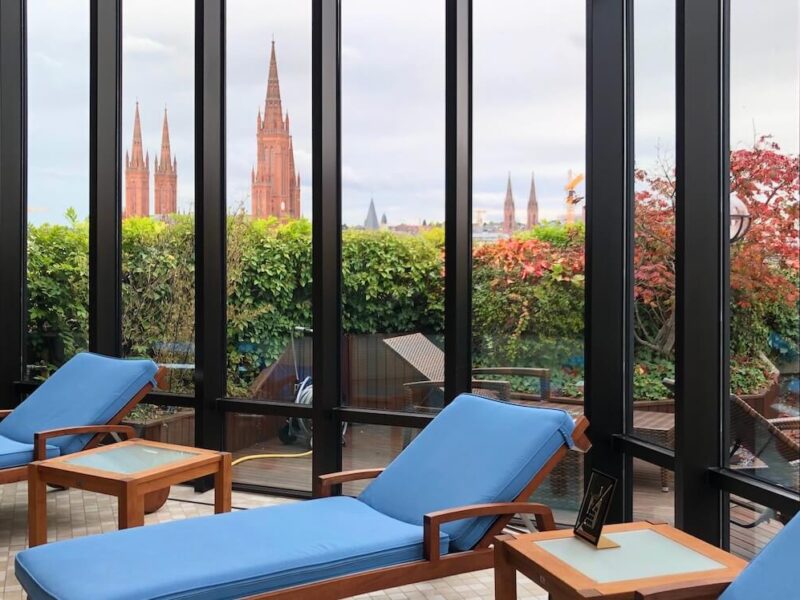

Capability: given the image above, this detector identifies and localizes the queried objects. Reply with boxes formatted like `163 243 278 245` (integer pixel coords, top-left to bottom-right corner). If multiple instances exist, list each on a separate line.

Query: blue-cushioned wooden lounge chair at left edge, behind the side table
0 352 164 484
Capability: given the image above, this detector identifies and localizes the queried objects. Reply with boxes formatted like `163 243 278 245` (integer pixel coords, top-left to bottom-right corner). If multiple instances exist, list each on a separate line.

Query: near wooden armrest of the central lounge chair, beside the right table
423 502 556 561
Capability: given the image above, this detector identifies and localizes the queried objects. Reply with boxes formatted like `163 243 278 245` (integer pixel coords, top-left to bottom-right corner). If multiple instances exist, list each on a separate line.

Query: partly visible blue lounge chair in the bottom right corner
636 516 800 600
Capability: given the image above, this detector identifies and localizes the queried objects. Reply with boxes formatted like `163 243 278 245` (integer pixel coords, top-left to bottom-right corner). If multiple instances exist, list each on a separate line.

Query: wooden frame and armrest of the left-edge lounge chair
0 367 167 485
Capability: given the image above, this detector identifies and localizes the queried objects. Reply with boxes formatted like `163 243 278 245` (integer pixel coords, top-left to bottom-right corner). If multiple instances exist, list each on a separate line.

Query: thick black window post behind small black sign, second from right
585 0 633 521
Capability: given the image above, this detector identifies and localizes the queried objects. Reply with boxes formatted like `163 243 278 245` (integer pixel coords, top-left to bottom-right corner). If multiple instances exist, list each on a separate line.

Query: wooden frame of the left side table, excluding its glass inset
28 439 231 548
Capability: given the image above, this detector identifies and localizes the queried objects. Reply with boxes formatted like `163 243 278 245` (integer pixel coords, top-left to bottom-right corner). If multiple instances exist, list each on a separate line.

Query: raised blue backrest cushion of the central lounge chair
359 394 575 550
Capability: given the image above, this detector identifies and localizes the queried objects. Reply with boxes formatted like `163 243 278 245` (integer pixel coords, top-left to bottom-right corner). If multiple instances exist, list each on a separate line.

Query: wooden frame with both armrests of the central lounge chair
248 416 591 600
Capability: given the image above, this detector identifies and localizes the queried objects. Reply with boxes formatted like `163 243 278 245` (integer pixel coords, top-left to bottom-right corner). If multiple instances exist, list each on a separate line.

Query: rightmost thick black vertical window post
675 0 730 544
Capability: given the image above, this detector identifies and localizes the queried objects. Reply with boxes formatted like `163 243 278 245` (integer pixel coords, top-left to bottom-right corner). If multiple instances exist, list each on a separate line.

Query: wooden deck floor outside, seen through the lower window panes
234 420 782 559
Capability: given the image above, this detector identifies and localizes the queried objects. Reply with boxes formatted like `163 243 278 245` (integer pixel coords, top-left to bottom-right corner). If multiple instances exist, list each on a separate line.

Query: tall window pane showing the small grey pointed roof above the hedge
342 0 445 410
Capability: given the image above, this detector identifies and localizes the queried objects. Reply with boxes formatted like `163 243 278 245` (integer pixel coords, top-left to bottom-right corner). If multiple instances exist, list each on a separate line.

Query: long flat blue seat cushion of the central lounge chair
16 497 448 600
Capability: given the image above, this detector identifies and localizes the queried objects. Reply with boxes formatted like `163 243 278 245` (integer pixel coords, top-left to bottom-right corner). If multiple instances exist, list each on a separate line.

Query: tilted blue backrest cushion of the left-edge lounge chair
0 352 158 454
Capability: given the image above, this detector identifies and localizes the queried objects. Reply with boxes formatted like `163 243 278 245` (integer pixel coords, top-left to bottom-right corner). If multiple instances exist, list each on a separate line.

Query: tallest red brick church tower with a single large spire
251 40 300 220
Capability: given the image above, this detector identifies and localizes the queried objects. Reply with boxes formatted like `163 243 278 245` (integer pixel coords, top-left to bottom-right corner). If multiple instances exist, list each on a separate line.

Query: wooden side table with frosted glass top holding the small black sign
494 522 747 600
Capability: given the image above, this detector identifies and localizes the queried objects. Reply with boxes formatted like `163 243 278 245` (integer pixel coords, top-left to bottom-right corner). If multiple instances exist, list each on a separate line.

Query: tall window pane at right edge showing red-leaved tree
728 0 800 492
